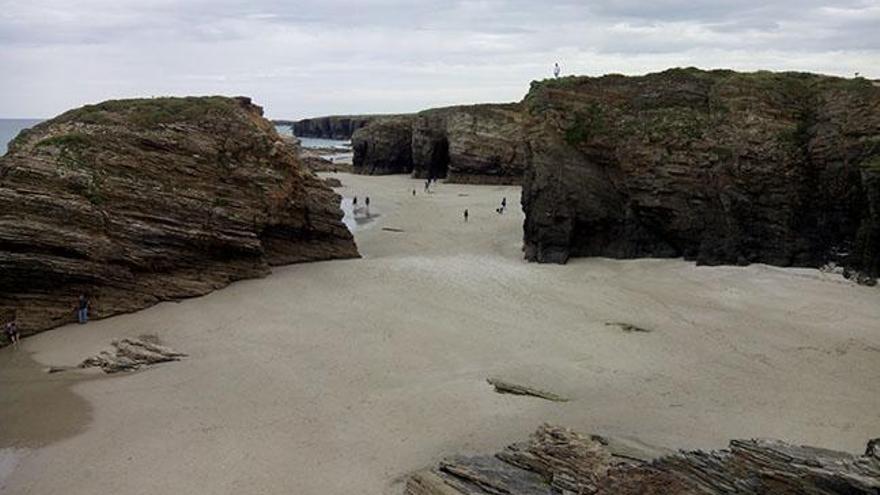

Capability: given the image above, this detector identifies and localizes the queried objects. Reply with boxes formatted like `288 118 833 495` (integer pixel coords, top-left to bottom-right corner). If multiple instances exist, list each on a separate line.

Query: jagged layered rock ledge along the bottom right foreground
405 425 880 495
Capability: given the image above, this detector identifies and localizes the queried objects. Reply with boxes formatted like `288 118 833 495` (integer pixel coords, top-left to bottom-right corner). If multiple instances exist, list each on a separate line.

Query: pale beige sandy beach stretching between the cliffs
0 174 880 495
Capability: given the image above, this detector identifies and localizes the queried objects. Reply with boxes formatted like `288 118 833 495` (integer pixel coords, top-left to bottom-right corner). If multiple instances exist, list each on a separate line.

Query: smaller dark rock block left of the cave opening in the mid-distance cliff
351 115 413 175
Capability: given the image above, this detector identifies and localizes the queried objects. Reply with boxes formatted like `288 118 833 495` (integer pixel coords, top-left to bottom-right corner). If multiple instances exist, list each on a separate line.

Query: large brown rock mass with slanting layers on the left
0 97 358 340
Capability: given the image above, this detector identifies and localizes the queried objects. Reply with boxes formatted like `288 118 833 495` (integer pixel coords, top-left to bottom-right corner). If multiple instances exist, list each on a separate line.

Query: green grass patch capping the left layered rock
53 96 237 128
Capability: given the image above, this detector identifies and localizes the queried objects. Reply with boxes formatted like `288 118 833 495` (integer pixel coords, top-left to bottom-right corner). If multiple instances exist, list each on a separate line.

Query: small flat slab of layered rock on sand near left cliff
79 337 186 373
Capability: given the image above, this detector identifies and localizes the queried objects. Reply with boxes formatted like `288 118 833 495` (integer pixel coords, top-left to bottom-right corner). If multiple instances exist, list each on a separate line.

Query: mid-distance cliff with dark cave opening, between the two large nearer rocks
352 104 528 184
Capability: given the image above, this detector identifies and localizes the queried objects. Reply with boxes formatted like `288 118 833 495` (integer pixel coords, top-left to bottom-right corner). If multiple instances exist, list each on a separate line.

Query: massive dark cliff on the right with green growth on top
522 69 880 274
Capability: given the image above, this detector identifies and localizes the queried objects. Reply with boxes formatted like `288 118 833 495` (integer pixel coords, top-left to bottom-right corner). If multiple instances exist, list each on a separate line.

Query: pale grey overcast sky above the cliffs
0 0 880 118
